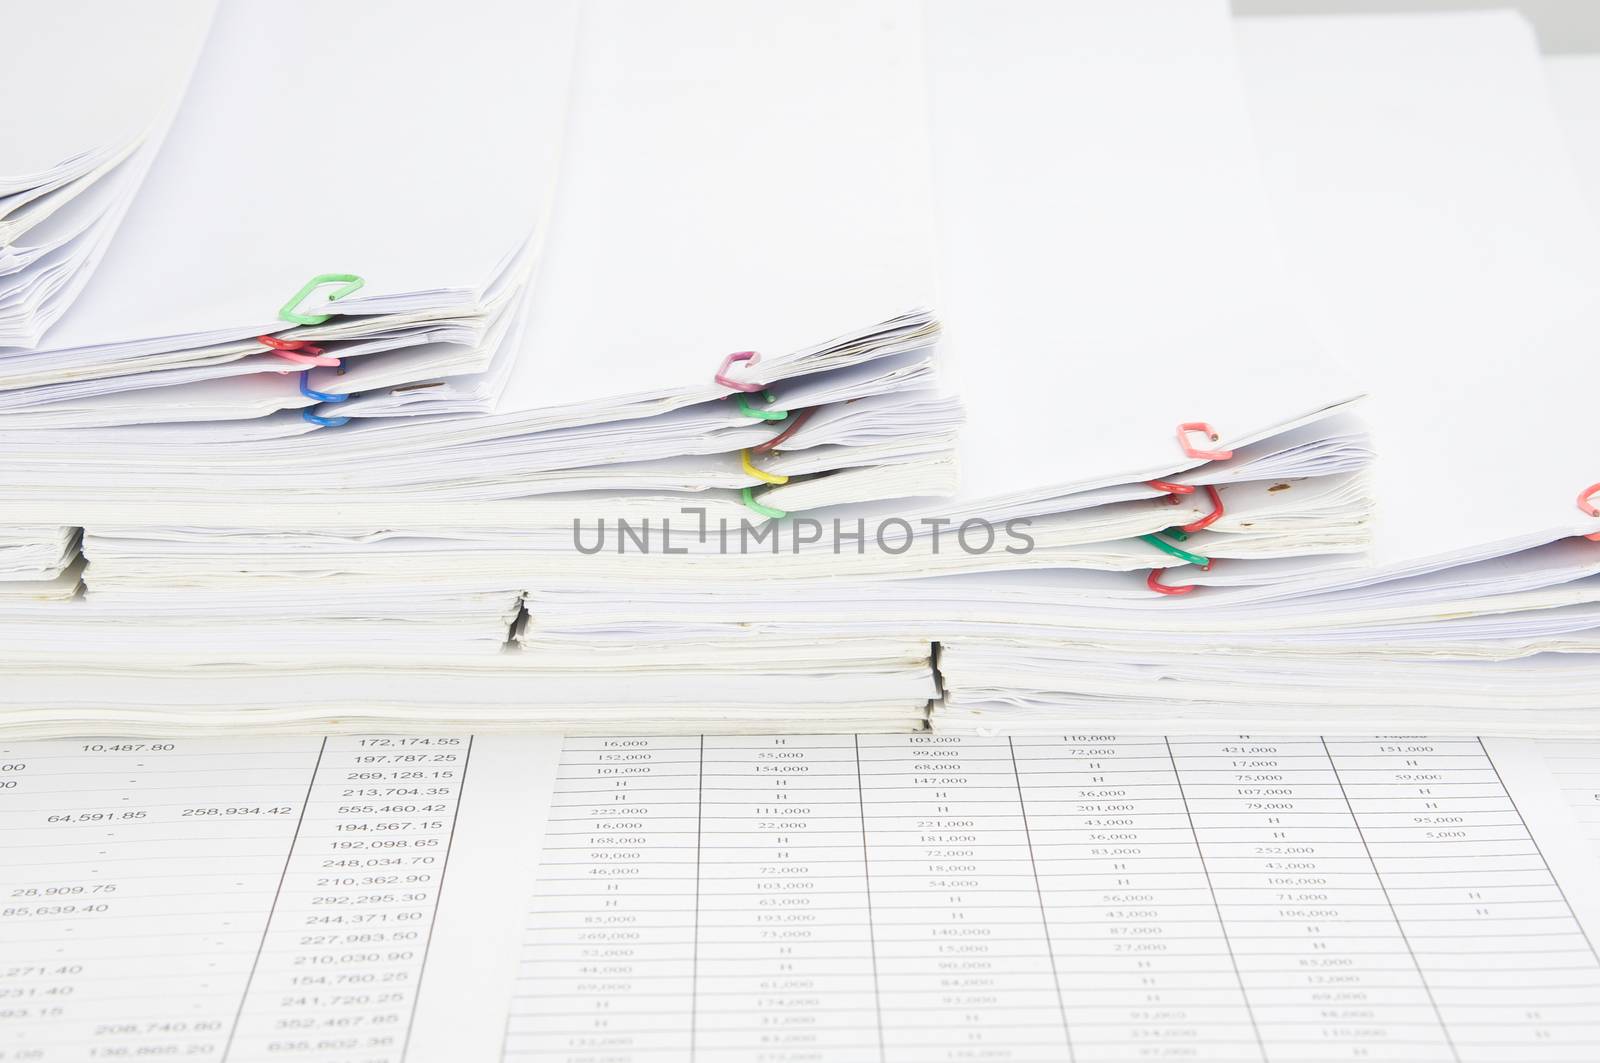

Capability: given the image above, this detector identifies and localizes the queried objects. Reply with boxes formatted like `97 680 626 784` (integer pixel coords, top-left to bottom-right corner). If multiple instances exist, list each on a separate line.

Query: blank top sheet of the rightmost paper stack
1237 11 1600 575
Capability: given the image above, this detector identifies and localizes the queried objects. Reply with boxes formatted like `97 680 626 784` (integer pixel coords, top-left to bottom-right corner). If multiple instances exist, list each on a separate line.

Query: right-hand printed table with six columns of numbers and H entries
506 735 1600 1063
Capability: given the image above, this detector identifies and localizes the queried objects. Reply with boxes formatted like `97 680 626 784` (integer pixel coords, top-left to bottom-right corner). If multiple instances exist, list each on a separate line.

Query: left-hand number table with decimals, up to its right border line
0 736 470 1063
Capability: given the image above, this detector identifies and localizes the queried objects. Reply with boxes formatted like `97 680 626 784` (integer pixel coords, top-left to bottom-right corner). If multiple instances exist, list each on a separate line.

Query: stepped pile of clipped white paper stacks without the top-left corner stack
0 0 1600 735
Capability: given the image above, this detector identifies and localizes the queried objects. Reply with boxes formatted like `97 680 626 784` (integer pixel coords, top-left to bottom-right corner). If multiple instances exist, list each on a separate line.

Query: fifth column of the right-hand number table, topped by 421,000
1170 736 1453 1063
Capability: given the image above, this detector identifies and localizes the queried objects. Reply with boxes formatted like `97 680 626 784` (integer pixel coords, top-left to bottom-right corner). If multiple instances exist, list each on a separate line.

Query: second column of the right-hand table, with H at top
694 735 880 1063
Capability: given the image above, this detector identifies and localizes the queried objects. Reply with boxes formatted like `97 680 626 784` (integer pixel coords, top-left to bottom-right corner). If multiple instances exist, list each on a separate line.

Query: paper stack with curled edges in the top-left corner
0 0 213 348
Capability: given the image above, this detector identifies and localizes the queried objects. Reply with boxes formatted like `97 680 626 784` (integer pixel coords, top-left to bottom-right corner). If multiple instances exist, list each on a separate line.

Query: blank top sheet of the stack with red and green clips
926 0 1360 505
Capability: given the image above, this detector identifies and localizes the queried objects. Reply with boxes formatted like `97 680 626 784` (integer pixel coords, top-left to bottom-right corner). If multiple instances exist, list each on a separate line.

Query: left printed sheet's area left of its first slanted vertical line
0 738 322 1063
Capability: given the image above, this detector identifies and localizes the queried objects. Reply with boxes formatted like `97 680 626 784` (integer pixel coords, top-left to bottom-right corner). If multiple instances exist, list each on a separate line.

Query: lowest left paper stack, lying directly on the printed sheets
0 632 938 738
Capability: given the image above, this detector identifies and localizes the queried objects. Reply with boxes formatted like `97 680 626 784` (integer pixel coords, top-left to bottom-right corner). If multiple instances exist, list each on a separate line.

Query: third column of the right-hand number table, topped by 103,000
859 735 1067 1063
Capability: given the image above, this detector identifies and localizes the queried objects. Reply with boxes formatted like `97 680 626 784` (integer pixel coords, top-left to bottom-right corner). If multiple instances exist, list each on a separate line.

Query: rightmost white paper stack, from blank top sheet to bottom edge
936 13 1600 732
